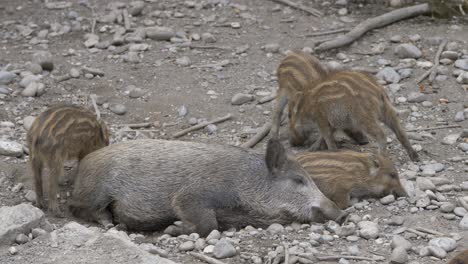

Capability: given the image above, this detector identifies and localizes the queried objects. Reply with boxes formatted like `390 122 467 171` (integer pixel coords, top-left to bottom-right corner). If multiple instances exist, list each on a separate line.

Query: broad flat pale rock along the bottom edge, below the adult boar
0 222 175 264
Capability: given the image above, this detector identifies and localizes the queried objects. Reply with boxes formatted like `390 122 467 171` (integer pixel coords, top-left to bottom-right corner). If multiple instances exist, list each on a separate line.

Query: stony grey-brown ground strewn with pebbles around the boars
0 0 468 264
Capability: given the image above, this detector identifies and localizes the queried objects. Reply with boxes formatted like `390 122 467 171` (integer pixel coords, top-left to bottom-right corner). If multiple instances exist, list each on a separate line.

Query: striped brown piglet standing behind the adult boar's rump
27 104 109 216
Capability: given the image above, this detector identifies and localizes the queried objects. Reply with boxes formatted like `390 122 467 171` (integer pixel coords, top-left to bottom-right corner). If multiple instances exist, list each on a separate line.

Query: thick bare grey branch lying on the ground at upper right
315 4 430 51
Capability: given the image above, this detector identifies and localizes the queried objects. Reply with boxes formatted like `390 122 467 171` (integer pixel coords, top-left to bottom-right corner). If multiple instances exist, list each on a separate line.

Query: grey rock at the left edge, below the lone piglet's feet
0 203 45 245
